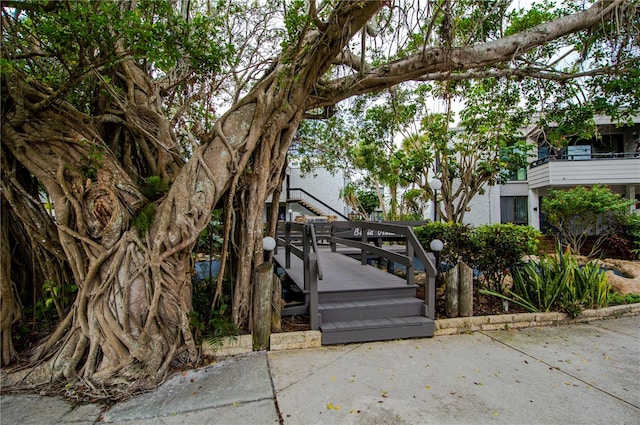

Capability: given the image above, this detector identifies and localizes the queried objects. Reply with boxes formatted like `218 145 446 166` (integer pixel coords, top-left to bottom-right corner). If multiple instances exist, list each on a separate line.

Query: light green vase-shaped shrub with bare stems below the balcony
542 185 633 256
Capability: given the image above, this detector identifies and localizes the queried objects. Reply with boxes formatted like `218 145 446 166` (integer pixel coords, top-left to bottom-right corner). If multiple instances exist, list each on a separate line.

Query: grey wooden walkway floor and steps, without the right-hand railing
274 222 434 344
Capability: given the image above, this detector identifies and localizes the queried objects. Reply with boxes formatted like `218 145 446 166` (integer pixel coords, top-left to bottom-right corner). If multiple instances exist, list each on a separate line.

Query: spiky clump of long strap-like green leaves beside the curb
480 247 611 317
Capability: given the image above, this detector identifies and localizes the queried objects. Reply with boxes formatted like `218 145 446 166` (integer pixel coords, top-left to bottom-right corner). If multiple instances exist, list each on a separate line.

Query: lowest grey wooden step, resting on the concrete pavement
320 316 435 345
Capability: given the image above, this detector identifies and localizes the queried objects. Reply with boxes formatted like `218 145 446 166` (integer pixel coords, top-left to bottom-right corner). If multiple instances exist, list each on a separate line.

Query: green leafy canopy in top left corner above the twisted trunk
2 0 234 112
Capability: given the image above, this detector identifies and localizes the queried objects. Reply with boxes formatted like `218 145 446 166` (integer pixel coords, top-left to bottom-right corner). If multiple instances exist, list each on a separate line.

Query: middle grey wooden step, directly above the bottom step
318 297 424 322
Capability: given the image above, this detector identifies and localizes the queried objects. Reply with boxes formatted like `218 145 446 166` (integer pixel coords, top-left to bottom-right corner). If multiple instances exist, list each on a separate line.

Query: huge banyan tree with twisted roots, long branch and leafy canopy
0 0 640 396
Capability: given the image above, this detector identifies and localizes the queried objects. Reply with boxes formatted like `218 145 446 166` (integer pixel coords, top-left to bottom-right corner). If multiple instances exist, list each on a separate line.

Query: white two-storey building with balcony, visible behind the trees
269 116 640 231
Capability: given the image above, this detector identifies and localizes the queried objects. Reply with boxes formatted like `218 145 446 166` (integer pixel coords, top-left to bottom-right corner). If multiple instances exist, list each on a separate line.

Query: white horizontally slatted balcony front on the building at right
528 152 640 189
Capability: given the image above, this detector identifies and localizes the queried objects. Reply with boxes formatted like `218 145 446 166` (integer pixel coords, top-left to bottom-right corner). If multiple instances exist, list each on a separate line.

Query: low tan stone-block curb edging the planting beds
202 303 640 357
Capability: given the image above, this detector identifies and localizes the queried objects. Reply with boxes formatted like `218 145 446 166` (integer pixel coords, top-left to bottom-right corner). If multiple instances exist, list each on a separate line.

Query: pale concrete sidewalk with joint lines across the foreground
0 316 640 425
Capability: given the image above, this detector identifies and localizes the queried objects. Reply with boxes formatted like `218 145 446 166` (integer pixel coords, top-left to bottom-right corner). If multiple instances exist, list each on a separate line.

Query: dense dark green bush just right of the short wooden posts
472 223 540 291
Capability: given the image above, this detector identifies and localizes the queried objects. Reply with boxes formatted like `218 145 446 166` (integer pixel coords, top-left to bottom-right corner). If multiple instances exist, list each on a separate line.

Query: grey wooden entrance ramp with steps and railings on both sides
274 222 435 345
